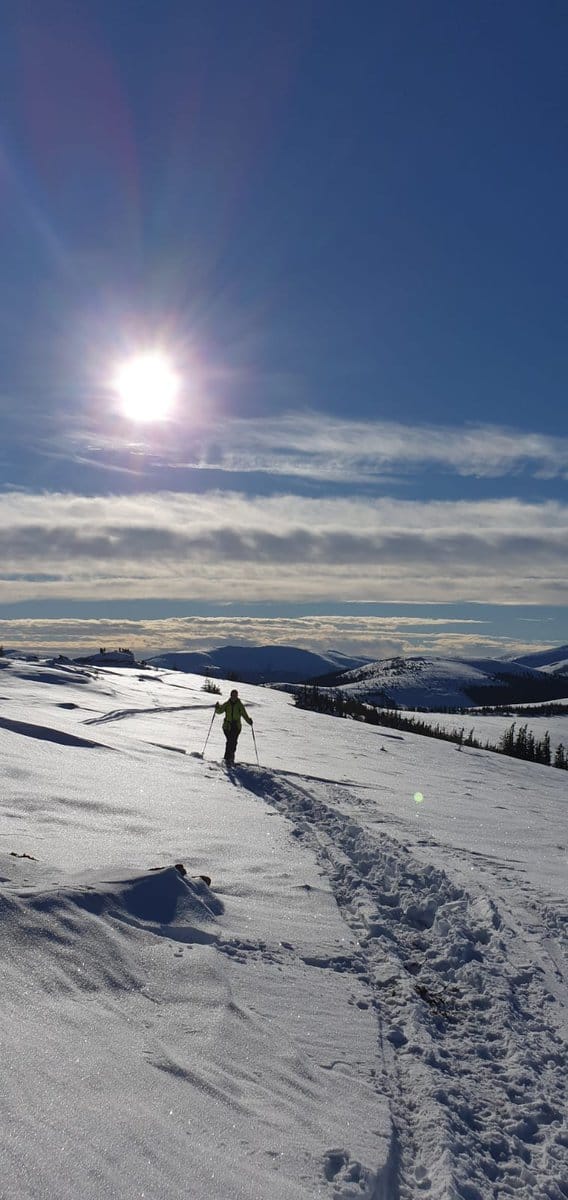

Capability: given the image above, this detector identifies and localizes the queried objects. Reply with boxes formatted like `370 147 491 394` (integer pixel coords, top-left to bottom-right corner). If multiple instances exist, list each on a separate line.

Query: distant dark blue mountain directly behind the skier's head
148 646 369 683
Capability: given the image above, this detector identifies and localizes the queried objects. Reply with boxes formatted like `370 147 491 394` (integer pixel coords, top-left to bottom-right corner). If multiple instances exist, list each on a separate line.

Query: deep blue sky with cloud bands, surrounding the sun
0 0 568 656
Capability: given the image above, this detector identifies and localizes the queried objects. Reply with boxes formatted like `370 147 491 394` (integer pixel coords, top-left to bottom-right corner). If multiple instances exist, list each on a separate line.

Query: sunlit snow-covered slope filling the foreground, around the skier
0 660 568 1200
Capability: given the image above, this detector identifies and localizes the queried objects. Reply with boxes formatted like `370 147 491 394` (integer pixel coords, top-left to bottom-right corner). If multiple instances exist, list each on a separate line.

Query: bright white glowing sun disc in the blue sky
114 352 179 422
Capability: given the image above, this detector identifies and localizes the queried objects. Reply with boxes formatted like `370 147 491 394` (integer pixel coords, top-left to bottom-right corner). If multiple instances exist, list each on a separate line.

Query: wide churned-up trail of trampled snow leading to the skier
225 767 568 1200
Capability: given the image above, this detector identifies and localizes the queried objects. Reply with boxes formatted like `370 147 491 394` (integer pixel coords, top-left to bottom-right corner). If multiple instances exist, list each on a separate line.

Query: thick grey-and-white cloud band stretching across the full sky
0 492 568 604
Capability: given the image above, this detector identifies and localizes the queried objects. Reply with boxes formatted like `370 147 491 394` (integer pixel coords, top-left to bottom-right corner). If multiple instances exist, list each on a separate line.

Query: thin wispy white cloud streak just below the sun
58 412 568 484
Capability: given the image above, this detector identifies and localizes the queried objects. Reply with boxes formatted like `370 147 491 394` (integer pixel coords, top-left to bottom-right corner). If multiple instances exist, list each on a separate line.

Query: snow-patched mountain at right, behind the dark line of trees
328 655 568 710
